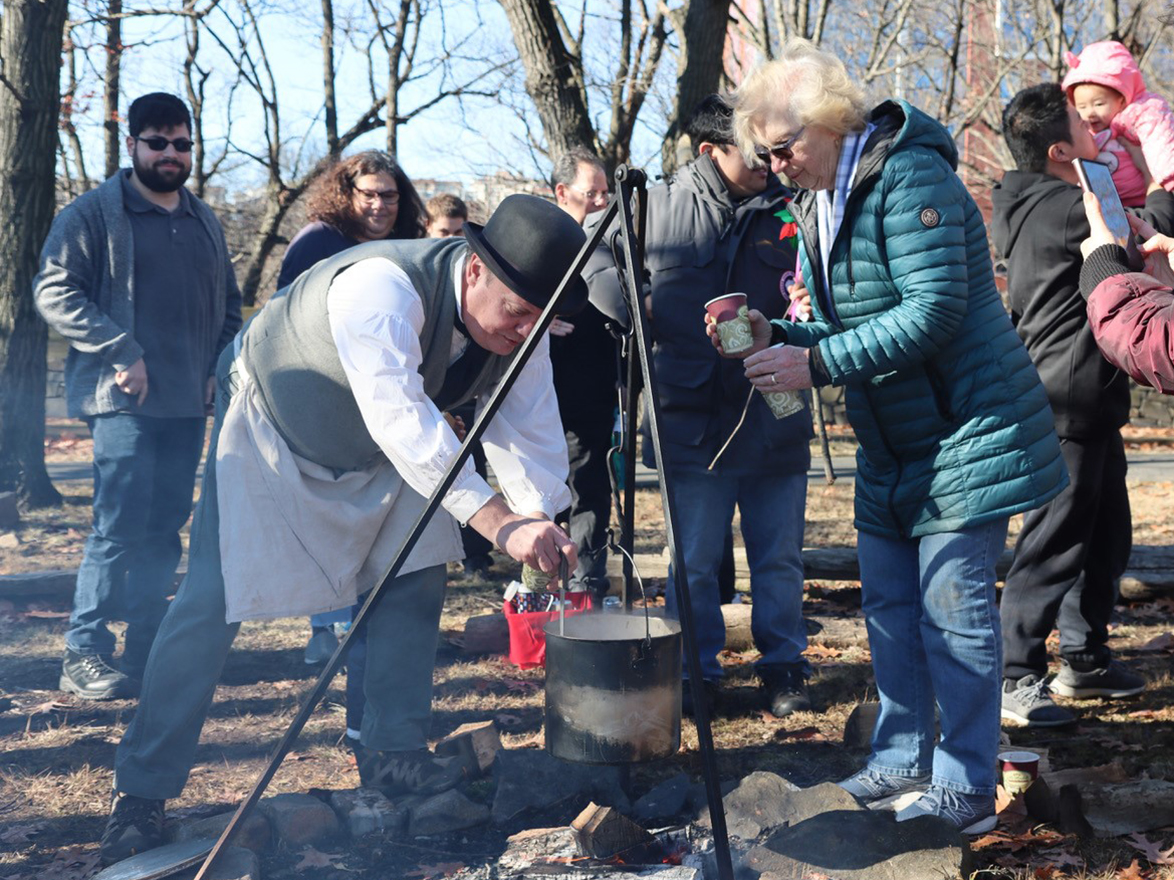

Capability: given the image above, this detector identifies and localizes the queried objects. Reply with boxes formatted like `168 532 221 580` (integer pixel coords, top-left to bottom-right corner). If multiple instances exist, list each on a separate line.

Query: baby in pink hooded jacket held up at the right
1064 40 1174 208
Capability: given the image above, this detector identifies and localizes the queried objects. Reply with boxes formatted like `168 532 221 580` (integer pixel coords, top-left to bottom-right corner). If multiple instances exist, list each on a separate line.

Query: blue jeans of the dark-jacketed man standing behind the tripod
666 466 808 679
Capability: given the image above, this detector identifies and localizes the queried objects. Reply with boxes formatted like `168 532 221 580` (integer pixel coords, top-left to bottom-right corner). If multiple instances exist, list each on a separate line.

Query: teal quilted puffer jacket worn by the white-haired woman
781 101 1068 539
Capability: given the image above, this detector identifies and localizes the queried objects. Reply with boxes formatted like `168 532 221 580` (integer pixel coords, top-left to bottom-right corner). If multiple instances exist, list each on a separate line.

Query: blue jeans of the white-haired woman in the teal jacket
856 519 1007 794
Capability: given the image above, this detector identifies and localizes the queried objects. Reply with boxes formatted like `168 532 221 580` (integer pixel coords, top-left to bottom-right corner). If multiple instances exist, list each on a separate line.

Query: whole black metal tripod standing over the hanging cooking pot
184 167 734 880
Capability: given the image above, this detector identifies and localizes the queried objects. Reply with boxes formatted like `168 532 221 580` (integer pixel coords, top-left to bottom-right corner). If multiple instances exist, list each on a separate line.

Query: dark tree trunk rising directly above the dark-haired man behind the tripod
661 0 730 174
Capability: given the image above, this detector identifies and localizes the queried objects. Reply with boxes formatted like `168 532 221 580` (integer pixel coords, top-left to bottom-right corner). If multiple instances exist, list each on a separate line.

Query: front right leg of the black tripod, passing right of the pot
615 165 734 880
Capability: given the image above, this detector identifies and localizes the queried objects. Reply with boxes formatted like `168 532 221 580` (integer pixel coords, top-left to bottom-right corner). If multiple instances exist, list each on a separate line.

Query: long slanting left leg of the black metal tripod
195 197 618 880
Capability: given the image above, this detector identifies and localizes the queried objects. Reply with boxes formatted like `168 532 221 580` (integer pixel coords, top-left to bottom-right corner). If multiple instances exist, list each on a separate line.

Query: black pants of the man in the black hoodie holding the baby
1001 431 1133 679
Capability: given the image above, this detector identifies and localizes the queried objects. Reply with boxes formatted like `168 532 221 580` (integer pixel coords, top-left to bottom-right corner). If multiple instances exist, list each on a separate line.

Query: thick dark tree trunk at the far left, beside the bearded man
0 0 67 507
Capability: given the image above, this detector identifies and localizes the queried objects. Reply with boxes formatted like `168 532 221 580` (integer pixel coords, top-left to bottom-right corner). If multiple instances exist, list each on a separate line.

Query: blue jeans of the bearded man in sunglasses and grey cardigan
66 413 204 673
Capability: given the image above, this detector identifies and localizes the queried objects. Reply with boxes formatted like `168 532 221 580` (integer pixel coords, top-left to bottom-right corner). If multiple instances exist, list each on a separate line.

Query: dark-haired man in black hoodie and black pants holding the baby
993 83 1174 726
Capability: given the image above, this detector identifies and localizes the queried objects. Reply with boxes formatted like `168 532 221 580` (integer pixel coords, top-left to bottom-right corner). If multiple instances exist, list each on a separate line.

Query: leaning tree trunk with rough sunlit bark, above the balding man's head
499 0 596 158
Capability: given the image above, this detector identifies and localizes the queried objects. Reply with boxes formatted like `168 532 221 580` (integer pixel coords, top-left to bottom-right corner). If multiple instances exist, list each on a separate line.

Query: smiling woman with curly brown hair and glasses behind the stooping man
277 150 427 290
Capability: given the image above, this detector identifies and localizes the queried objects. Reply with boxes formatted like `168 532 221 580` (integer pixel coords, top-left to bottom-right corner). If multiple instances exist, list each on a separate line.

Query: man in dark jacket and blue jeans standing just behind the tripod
588 95 811 716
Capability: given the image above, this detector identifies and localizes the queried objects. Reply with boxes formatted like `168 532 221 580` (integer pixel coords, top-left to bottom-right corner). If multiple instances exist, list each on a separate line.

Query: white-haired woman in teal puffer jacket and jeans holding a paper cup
710 41 1067 833
